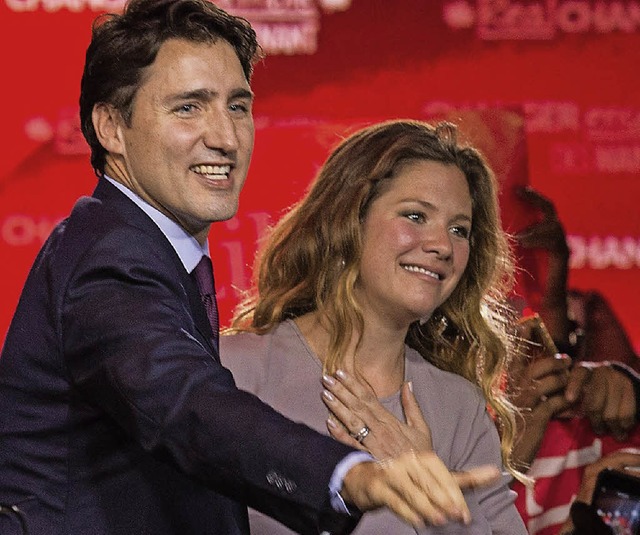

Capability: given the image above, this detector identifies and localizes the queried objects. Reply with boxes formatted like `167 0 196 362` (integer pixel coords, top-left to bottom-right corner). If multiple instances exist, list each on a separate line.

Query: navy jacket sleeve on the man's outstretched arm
53 204 357 533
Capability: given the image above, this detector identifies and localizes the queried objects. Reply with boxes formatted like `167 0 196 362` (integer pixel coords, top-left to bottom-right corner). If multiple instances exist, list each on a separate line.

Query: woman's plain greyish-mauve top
220 321 526 535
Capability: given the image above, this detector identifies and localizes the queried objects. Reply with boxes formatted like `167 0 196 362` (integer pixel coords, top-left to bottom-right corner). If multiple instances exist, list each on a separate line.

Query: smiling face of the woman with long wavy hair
356 160 472 327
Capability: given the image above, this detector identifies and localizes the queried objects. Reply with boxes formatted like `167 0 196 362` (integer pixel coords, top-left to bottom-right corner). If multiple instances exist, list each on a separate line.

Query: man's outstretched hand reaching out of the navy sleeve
340 452 500 528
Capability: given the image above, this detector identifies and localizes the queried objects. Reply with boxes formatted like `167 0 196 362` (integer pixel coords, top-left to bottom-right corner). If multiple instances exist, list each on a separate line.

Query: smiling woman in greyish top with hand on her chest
221 120 526 535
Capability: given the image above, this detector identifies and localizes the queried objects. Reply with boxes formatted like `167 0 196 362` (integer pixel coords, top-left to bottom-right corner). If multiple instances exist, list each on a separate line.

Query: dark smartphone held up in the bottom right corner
591 469 640 535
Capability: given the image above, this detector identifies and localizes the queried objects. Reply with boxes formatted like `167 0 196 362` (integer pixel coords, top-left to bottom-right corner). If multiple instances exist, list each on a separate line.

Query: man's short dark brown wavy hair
80 0 261 176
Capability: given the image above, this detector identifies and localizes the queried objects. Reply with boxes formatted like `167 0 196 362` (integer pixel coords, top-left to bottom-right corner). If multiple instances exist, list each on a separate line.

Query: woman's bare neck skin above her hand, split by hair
295 312 406 398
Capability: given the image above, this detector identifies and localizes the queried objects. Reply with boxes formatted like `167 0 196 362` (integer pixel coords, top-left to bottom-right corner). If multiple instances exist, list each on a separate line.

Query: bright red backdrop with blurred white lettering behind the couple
0 0 640 354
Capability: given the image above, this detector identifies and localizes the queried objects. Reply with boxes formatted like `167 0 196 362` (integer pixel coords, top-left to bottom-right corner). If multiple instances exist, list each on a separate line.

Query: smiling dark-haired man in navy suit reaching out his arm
0 0 495 535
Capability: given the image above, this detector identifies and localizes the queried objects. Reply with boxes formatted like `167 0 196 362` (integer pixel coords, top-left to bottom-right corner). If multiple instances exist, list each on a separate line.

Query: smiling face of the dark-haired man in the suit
107 39 254 243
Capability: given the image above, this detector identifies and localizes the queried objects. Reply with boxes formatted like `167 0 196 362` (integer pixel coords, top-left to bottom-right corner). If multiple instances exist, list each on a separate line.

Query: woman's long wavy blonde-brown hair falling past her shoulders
231 120 526 480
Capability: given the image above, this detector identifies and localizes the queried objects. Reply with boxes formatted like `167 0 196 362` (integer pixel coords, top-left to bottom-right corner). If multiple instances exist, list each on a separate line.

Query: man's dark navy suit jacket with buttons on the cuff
0 180 356 535
